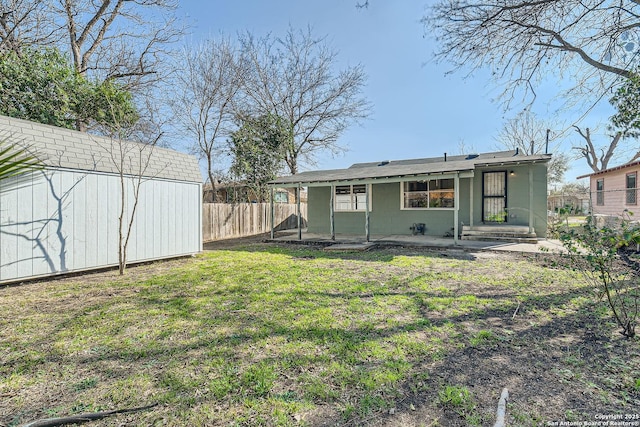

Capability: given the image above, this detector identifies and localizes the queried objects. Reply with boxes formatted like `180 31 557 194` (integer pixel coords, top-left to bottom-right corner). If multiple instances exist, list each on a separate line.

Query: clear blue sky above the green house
178 0 608 181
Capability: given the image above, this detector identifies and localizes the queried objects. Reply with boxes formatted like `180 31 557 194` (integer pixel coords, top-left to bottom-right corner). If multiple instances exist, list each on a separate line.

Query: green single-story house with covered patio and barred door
270 150 551 244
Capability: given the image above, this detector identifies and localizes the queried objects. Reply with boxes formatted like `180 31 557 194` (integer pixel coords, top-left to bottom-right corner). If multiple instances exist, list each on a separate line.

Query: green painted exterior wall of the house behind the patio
307 163 547 237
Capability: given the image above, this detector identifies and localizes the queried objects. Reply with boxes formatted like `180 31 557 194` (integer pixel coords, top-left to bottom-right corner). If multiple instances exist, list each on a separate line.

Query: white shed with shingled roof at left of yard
0 116 202 282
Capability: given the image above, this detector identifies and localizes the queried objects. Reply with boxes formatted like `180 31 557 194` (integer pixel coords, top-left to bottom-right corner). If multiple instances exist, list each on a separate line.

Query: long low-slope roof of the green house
270 150 551 185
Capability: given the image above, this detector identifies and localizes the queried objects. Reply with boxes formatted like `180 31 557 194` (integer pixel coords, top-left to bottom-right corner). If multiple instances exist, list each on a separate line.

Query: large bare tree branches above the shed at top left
0 0 184 130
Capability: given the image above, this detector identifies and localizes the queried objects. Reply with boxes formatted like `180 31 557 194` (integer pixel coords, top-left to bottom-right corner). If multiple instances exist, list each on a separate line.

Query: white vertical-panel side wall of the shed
0 169 202 282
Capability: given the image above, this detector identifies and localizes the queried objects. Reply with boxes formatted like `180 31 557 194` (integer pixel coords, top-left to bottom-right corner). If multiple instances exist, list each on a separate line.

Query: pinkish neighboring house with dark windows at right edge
577 161 640 219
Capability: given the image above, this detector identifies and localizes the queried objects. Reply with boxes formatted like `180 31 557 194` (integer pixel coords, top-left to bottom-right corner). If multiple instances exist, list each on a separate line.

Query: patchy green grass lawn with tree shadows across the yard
0 244 640 426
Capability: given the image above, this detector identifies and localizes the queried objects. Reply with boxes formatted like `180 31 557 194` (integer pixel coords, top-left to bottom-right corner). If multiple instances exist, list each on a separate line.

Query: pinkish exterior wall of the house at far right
589 164 640 220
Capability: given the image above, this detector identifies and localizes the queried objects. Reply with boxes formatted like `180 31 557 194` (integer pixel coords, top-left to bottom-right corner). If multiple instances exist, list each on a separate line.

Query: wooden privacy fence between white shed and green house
202 203 307 242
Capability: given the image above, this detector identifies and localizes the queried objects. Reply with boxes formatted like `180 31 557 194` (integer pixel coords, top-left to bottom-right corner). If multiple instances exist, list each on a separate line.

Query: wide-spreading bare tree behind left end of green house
241 29 370 174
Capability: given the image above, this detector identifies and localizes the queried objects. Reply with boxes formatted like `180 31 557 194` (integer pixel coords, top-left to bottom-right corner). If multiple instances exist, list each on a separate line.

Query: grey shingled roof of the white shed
0 116 202 182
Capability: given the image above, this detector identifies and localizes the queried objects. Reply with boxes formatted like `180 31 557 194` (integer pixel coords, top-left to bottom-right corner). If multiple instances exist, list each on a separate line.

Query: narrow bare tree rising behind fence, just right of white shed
171 37 245 195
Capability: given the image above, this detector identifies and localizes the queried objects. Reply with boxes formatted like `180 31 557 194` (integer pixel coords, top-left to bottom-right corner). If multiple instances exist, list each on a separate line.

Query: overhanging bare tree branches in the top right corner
423 0 640 106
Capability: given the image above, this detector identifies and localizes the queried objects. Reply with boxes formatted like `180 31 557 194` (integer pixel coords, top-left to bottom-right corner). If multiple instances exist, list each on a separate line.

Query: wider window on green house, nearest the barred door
402 179 455 209
